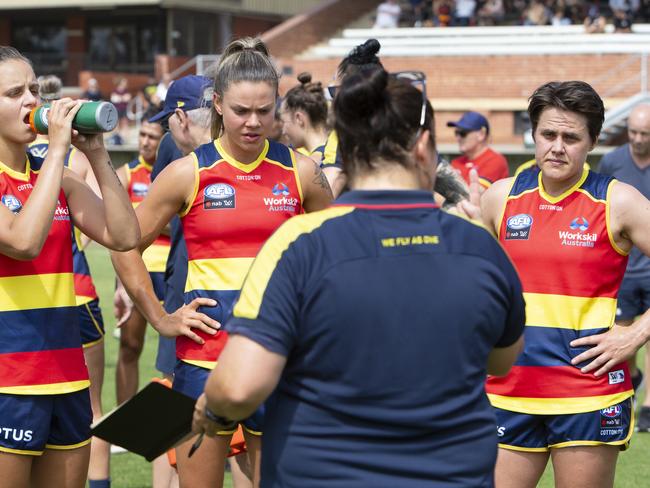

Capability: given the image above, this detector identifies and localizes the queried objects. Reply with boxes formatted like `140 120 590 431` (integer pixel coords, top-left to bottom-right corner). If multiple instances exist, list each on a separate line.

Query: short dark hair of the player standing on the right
528 81 605 143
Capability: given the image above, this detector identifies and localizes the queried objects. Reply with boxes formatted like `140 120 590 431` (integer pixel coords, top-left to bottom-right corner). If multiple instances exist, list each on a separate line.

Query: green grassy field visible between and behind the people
87 245 650 488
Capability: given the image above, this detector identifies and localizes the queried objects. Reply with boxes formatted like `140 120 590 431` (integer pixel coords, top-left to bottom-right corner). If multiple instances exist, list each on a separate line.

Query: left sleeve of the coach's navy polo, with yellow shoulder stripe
225 233 306 357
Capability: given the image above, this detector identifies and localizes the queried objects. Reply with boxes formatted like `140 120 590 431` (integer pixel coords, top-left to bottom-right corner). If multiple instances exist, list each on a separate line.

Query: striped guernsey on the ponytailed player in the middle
176 141 303 369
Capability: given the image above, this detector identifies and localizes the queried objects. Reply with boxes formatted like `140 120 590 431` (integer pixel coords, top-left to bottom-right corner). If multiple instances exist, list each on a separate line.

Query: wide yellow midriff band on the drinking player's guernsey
0 273 77 312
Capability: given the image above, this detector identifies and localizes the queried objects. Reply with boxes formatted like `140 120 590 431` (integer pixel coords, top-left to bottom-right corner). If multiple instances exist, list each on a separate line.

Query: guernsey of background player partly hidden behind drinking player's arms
126 156 171 273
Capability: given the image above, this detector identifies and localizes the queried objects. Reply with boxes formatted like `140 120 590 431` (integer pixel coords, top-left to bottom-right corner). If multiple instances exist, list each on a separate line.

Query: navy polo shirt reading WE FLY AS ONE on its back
226 191 524 488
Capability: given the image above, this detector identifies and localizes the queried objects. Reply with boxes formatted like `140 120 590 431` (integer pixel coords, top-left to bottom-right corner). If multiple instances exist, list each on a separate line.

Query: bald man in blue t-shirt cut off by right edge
598 105 650 416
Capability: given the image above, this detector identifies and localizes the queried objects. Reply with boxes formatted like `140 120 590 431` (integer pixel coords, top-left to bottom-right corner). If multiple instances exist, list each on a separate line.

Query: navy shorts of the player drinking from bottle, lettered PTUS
0 388 93 456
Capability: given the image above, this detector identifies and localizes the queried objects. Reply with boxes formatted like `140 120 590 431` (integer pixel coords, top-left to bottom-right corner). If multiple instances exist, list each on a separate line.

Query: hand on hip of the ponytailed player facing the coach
152 297 221 345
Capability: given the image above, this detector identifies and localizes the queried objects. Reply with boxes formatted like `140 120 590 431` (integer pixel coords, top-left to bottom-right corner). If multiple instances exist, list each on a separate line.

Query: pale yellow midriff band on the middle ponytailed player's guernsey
185 258 254 291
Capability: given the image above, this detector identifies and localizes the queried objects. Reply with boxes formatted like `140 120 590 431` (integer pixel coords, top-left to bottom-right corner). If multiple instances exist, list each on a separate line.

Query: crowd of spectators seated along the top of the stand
375 0 650 28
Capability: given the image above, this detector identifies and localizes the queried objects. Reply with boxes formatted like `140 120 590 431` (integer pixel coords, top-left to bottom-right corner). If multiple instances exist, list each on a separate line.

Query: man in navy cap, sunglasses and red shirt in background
447 112 508 187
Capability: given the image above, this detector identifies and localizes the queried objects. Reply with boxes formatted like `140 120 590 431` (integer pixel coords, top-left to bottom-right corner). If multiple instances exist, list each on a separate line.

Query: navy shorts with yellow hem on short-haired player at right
494 398 634 452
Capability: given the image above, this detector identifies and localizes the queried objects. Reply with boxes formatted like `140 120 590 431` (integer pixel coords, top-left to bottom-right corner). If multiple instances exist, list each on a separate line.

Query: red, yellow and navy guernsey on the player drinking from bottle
0 155 89 395
